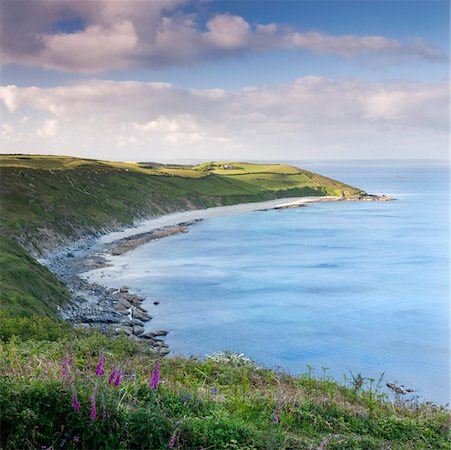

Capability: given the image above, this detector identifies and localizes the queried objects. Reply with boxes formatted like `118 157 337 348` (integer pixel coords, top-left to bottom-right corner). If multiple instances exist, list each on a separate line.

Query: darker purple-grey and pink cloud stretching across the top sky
2 0 447 74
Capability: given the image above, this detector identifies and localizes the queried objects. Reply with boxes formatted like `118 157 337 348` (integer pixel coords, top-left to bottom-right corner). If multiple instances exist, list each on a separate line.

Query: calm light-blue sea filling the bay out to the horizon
91 161 449 403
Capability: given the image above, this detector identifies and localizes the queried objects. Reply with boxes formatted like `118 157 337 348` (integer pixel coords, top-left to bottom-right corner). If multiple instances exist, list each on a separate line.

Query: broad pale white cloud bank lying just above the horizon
1 77 449 160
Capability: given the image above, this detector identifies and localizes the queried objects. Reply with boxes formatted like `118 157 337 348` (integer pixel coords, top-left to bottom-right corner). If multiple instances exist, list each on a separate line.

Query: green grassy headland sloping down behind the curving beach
0 155 361 253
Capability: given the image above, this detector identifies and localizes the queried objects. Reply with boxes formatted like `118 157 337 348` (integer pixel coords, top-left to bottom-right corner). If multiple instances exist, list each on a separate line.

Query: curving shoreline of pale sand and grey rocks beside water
41 196 392 356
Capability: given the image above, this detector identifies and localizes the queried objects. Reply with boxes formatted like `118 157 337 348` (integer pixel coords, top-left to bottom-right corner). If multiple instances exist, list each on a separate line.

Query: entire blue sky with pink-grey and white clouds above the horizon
0 0 449 161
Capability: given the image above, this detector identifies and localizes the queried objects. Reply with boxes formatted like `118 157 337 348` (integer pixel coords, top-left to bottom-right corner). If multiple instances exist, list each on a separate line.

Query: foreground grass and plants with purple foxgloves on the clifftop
0 319 449 450
